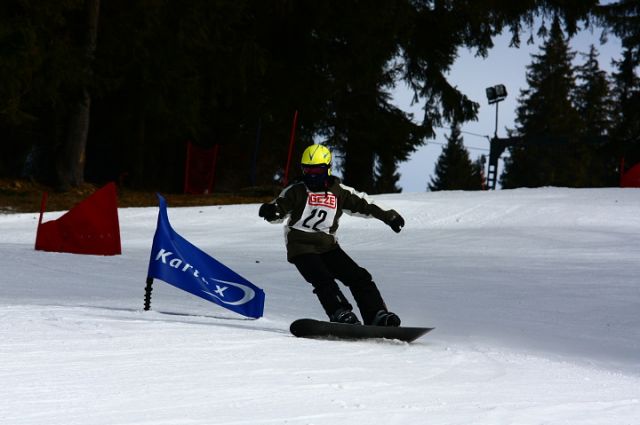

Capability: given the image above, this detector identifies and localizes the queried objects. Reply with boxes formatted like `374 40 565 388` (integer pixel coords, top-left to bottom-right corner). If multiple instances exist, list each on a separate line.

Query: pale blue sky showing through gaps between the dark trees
394 24 622 192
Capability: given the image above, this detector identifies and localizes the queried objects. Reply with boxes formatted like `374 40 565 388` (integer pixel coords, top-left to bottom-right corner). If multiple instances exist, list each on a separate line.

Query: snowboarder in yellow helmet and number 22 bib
258 145 404 326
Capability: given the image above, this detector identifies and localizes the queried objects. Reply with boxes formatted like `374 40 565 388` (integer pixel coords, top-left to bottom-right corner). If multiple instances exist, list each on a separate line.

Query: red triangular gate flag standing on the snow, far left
36 183 122 255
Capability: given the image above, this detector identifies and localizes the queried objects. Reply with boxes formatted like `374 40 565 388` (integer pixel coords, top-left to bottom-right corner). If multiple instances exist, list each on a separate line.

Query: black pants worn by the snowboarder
293 247 386 324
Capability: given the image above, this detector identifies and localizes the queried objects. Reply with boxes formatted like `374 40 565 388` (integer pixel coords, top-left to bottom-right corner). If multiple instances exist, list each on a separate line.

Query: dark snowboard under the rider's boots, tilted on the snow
289 319 434 342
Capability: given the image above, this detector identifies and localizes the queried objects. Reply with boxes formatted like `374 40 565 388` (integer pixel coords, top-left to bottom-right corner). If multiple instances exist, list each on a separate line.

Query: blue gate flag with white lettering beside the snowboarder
147 195 264 319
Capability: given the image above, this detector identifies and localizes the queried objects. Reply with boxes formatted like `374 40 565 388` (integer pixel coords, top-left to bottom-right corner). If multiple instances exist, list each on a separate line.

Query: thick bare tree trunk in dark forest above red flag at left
56 0 100 190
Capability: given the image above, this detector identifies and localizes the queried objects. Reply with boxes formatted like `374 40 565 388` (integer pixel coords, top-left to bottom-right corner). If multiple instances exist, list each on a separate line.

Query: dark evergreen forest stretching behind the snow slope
0 0 640 193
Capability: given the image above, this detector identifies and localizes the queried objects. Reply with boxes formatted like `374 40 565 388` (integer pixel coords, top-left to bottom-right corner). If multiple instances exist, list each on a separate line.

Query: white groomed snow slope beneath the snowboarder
0 188 640 425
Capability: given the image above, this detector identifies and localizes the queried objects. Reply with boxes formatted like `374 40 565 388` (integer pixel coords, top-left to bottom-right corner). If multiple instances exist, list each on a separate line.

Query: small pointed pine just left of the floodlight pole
428 124 482 191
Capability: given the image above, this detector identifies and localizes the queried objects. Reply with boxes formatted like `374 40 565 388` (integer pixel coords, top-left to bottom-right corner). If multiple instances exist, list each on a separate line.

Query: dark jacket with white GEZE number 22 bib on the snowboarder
264 176 397 261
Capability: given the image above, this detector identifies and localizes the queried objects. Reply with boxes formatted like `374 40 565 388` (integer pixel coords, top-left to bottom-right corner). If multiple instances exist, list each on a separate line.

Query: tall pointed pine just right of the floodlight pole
501 18 588 188
